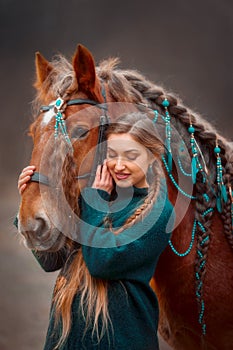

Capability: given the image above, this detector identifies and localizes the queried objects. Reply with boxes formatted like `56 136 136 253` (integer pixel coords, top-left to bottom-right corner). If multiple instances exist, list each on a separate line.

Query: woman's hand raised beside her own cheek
92 161 113 194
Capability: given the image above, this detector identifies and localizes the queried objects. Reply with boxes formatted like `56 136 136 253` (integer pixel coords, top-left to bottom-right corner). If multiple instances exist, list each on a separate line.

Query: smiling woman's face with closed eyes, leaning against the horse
107 134 152 188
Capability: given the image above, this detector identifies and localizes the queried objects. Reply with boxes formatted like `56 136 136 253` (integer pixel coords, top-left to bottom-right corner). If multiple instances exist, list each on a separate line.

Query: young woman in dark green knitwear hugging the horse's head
18 113 174 350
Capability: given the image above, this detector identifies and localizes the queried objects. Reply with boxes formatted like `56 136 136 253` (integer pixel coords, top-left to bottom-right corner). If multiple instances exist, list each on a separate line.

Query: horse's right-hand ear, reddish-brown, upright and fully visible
73 44 100 98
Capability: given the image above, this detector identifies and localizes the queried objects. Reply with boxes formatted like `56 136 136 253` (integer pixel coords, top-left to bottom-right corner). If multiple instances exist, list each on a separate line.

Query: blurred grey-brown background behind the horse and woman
0 0 233 350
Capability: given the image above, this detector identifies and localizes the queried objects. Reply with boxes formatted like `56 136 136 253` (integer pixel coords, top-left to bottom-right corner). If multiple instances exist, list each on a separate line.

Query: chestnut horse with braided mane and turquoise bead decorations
19 45 233 350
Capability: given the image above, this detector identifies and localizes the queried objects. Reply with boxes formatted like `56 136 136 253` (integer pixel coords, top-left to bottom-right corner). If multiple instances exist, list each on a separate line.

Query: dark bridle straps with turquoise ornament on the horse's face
30 89 109 186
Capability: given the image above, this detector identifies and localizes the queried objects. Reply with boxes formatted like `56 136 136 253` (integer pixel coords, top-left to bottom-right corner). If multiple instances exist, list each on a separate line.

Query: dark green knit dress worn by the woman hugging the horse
37 185 174 350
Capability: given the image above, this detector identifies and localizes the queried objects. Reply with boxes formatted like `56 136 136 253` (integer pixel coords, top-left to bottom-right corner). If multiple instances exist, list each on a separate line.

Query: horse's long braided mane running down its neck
94 59 233 349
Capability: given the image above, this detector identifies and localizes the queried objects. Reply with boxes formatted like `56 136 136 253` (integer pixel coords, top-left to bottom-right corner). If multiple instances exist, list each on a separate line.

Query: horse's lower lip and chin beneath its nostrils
23 231 66 253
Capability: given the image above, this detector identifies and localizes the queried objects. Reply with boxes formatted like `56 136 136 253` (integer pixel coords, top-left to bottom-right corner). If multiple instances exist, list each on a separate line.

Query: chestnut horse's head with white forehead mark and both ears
18 45 107 251
